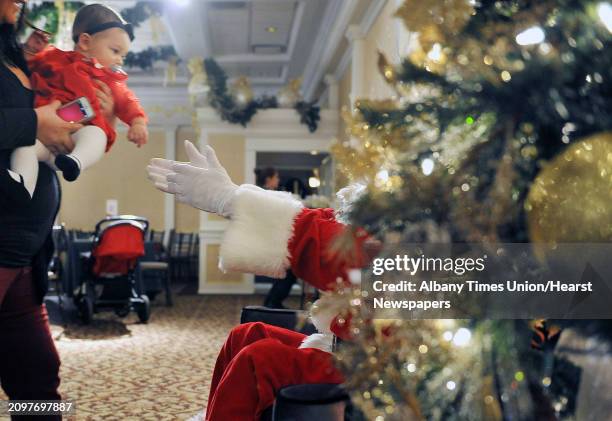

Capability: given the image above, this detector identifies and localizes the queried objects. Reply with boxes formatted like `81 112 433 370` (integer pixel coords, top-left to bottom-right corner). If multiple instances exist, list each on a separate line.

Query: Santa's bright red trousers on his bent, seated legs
206 323 344 421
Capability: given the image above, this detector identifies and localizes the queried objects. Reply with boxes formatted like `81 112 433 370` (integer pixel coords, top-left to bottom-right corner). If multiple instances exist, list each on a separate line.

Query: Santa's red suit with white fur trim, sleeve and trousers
205 186 366 421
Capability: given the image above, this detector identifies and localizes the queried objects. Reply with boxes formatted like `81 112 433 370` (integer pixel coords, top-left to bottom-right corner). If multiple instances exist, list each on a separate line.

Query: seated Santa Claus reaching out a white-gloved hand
147 141 367 421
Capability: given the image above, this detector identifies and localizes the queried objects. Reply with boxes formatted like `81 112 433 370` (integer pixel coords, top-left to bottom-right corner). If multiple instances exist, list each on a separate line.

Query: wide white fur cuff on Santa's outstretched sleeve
219 185 302 278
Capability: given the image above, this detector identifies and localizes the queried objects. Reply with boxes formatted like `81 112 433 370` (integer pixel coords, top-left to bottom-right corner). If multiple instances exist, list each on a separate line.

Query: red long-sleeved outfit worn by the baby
29 46 146 152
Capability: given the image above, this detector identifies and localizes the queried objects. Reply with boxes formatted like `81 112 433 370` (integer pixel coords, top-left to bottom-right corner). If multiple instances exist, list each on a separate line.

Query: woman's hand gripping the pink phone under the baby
34 101 83 155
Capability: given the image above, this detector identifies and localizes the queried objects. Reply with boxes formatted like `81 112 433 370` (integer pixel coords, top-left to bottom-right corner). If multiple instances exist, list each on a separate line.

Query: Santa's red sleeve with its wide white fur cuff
220 185 366 290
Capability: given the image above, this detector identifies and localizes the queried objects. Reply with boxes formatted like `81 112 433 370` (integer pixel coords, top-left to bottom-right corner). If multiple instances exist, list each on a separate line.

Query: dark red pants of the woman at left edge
0 267 61 420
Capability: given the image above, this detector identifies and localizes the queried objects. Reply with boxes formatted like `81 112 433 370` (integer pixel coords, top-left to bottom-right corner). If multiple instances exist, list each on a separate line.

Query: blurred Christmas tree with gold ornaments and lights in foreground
334 0 612 421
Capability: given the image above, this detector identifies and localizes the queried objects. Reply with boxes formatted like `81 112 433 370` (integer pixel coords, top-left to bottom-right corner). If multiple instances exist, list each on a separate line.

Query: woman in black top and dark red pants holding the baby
0 0 114 414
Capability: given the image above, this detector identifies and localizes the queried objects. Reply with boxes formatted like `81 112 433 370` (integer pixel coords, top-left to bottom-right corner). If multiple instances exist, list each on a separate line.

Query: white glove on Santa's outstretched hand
147 141 238 218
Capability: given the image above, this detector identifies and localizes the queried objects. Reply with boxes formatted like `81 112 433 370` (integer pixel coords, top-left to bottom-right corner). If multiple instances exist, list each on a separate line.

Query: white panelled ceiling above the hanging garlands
56 0 385 113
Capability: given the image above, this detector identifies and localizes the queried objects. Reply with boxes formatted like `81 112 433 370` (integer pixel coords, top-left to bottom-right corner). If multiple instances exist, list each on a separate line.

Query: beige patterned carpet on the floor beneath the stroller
0 295 274 420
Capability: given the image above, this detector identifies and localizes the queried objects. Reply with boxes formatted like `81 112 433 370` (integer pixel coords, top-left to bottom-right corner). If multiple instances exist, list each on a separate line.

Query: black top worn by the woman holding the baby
0 61 60 298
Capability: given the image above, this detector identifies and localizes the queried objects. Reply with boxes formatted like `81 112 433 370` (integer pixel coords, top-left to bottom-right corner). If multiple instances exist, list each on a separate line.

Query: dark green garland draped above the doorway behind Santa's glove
204 58 321 133
